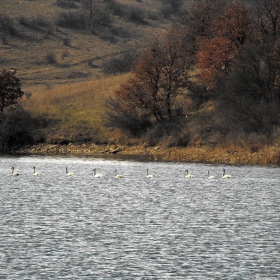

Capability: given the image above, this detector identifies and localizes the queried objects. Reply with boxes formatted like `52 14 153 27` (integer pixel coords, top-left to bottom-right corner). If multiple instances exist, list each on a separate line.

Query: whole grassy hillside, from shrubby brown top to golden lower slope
0 0 179 143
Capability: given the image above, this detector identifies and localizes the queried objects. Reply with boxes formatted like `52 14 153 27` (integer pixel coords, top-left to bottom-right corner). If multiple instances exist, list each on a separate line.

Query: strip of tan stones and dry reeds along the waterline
12 143 280 166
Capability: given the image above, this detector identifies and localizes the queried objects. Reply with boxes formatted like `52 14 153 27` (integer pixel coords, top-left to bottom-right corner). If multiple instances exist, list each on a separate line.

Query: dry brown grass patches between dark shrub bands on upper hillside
0 0 170 93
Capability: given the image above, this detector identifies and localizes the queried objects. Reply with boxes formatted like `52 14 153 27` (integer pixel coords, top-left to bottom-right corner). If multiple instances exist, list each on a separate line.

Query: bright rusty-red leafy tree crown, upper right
196 5 251 89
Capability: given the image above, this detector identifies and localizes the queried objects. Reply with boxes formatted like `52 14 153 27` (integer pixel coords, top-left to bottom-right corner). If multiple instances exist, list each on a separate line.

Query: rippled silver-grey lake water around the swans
0 156 280 280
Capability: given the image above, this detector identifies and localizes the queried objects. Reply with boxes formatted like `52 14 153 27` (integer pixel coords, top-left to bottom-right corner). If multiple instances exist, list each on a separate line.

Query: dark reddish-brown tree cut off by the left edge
0 70 24 115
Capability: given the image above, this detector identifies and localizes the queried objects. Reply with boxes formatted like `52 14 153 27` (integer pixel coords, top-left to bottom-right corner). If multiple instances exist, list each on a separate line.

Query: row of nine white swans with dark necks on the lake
11 166 232 179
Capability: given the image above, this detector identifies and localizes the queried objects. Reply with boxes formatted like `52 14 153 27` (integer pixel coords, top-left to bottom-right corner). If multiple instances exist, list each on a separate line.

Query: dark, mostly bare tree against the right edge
213 0 280 137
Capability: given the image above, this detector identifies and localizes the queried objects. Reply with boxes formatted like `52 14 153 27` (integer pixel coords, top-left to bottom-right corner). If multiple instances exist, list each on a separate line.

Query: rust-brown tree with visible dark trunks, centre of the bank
106 32 191 135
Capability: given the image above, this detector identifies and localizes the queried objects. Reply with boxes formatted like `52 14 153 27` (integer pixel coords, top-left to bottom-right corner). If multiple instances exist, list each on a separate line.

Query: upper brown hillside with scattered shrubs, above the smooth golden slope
0 0 171 93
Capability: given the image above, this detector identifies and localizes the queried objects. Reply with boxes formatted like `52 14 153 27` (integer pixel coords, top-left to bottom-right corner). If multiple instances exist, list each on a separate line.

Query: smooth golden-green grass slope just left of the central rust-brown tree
22 74 129 142
